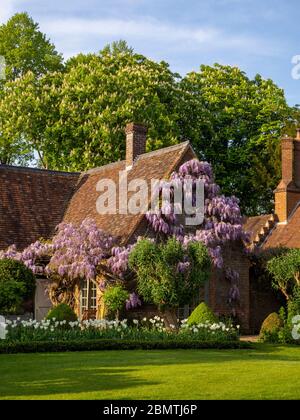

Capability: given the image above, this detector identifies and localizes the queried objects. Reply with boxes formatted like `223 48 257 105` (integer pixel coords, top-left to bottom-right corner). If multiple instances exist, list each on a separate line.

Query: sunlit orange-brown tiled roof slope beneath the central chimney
64 142 195 241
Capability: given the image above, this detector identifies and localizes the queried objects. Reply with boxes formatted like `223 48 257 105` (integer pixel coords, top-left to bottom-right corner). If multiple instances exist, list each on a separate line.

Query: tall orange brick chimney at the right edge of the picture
275 129 300 223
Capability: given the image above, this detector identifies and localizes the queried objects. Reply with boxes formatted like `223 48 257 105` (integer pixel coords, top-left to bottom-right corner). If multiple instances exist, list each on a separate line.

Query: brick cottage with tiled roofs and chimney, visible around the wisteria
0 124 251 332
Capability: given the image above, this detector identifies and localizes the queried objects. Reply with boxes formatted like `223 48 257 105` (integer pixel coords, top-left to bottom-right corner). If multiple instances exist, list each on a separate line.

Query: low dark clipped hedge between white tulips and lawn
0 340 253 354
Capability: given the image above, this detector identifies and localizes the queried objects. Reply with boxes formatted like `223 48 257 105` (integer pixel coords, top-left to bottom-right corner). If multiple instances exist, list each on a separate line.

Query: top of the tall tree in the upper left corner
0 13 63 80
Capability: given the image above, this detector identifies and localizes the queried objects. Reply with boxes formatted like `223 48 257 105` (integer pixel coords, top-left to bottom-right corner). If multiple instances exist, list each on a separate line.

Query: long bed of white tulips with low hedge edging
0 316 251 353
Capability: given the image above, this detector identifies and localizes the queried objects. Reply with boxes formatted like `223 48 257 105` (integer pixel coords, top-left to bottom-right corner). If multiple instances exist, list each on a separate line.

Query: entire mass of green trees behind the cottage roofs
0 13 300 215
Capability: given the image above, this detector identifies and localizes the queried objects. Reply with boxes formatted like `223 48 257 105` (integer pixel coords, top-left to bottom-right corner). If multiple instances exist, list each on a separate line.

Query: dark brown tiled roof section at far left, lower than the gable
0 165 79 249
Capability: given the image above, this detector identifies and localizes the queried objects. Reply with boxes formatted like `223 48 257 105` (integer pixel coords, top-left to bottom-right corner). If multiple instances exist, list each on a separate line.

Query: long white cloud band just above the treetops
40 17 277 57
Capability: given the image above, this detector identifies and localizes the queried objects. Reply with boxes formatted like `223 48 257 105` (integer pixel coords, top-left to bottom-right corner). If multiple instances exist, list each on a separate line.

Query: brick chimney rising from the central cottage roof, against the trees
125 123 147 169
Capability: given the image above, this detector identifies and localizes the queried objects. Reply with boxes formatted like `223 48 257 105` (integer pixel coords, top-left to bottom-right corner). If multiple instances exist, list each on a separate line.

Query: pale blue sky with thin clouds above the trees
0 0 300 105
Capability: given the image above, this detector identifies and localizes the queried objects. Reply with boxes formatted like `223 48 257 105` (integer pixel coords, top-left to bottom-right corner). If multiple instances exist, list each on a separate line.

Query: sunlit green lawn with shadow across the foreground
0 344 300 399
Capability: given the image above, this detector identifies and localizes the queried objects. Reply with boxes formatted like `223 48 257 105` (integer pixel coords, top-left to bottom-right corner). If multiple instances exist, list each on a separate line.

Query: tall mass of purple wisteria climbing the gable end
146 159 247 270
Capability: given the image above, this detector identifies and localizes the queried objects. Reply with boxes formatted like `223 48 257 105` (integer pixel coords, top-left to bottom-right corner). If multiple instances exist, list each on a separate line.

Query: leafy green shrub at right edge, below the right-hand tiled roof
267 249 300 300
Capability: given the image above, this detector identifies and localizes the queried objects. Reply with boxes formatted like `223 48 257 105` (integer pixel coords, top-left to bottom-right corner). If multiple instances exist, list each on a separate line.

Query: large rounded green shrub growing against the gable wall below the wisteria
129 238 211 307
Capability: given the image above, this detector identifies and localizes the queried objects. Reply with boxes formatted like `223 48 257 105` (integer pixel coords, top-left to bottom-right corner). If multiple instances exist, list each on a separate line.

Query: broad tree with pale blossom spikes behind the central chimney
0 39 179 171
